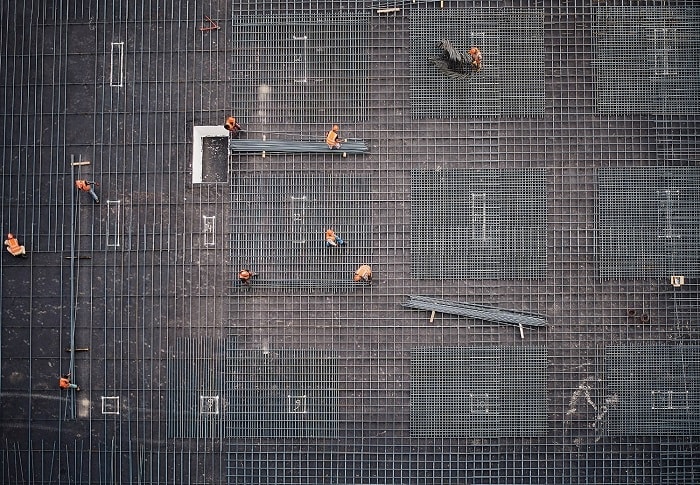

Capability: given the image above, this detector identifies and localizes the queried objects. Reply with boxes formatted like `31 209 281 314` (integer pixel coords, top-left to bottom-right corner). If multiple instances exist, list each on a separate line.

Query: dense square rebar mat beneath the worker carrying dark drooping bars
410 7 544 118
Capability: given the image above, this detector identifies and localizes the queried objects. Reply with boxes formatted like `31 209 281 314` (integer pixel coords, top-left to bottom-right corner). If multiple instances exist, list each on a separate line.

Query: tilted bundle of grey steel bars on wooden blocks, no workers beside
402 295 547 327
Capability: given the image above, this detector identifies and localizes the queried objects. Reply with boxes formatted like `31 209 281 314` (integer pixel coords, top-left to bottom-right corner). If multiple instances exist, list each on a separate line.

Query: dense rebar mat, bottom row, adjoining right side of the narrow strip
226 349 339 443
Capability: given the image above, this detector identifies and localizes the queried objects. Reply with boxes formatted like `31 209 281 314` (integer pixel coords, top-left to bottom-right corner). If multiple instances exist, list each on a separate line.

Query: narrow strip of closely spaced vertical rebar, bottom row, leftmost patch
167 337 235 438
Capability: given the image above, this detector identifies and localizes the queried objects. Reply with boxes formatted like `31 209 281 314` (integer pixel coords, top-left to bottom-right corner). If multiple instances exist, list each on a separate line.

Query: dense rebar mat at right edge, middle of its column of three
598 167 700 278
